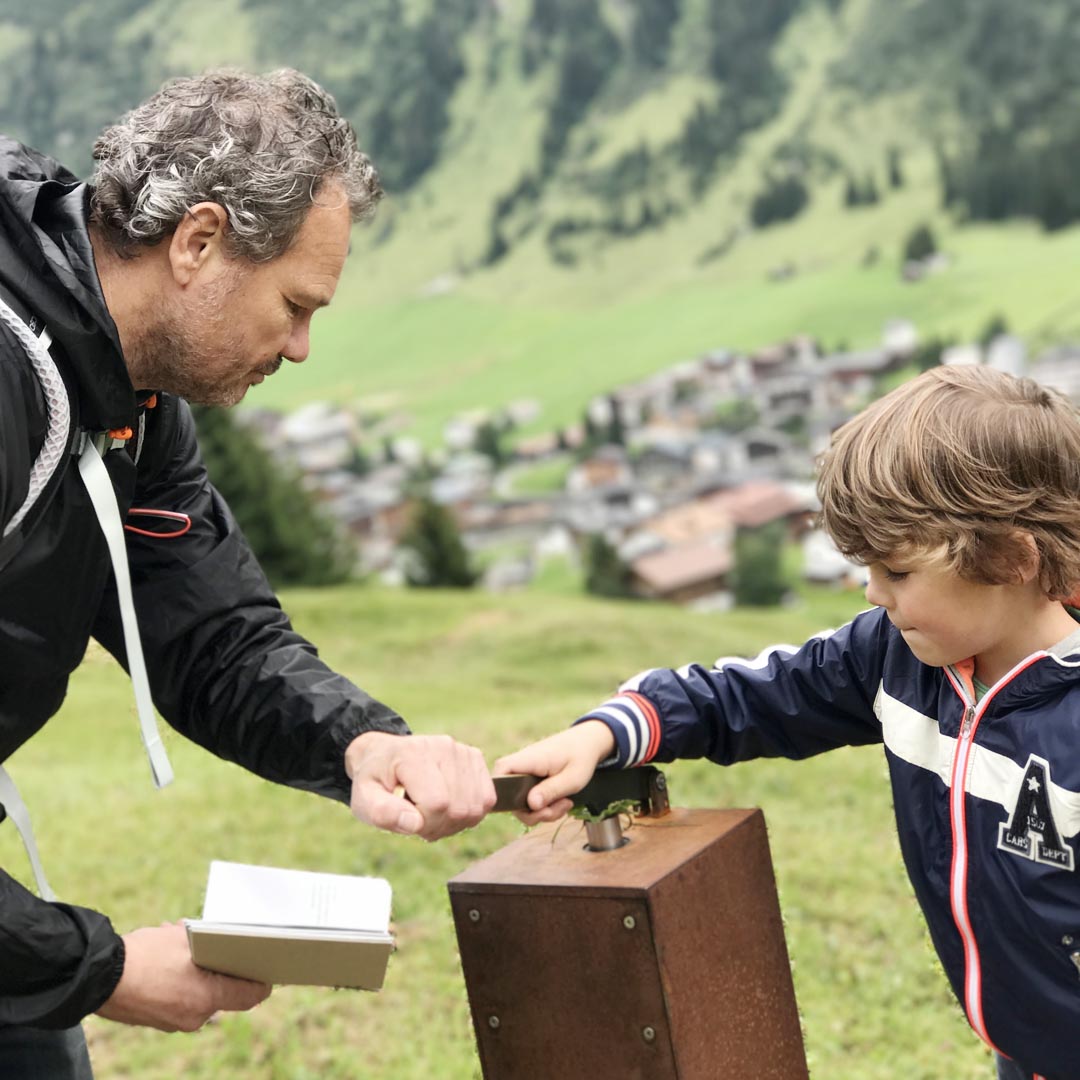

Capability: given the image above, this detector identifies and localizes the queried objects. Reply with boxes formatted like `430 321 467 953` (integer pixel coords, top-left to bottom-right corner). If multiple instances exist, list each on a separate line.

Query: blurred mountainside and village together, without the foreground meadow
0 0 1080 607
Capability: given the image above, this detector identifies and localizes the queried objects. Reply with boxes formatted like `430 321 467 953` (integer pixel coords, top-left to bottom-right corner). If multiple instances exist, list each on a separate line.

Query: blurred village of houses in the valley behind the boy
242 320 1062 610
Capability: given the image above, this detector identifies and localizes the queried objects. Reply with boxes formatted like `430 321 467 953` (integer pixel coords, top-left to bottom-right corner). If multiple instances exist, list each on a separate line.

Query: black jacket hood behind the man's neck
0 135 135 429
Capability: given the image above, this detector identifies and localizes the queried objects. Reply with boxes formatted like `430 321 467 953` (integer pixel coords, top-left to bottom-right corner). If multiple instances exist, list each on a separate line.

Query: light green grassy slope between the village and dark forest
251 0 1080 441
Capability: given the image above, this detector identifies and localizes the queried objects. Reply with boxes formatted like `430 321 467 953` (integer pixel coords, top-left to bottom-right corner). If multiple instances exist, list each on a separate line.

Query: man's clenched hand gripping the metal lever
345 731 495 840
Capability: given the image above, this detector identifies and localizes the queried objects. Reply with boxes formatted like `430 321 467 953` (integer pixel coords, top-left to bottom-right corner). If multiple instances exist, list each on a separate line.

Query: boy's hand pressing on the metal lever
491 720 615 825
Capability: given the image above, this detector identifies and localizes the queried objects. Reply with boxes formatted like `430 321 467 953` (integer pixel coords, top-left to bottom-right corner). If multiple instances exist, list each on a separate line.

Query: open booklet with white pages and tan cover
185 861 394 990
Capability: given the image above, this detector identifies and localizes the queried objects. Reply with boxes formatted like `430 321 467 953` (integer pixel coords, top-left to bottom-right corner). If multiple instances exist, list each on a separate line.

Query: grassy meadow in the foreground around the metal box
0 585 991 1080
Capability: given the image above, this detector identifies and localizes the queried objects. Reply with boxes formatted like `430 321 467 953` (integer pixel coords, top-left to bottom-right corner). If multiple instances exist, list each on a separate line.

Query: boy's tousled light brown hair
818 365 1080 599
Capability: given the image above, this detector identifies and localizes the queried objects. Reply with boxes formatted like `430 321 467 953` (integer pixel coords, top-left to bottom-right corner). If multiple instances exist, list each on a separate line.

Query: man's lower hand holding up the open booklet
97 922 271 1031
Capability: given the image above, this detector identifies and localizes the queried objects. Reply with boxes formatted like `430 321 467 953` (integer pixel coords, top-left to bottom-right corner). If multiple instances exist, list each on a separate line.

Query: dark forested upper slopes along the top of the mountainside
0 0 1080 230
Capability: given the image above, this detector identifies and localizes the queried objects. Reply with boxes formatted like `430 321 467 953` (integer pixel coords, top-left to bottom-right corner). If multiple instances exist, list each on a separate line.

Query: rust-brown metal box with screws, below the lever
449 810 808 1080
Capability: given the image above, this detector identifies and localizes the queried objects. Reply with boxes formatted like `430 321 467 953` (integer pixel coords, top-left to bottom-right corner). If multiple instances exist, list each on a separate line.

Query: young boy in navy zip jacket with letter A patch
495 366 1080 1080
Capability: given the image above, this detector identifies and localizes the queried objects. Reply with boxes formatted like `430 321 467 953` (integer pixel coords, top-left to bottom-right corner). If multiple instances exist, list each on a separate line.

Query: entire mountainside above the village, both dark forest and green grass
0 0 1080 434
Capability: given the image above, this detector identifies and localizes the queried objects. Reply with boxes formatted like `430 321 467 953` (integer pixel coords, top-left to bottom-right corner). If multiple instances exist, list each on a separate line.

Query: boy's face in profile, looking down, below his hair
866 556 1032 670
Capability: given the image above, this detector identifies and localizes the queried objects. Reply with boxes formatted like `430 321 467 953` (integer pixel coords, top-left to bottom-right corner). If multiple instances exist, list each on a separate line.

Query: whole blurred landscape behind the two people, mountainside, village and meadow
0 0 1080 1080
